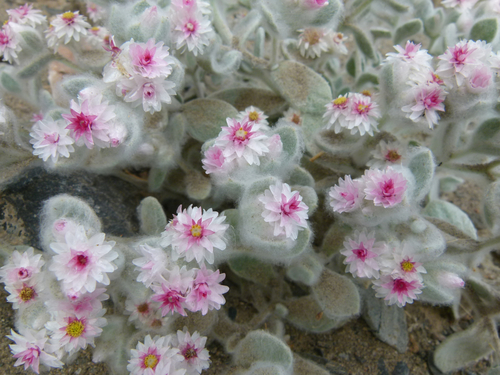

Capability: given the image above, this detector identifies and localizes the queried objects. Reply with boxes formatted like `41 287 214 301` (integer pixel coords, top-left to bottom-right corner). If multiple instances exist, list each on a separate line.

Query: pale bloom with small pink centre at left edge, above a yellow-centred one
0 247 45 286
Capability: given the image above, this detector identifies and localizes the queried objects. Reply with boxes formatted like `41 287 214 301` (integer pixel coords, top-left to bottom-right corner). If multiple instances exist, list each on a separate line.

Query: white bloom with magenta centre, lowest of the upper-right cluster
401 84 446 129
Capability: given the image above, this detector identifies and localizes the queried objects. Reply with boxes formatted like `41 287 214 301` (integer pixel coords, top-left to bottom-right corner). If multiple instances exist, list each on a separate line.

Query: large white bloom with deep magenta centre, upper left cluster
62 90 116 148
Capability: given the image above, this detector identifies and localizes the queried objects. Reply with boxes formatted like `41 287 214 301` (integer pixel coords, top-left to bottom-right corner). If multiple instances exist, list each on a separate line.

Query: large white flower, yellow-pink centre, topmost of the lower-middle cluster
169 205 229 264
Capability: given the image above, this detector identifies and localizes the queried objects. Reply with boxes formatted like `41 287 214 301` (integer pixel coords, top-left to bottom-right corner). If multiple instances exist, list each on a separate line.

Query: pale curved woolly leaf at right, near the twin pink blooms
422 200 477 240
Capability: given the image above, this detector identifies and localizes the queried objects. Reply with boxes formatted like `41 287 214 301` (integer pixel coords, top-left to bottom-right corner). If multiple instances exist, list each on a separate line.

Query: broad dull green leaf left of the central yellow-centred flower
182 99 238 142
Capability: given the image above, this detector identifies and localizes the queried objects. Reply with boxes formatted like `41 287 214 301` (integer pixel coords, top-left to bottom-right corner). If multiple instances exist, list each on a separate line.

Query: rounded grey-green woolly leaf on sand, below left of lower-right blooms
312 269 361 318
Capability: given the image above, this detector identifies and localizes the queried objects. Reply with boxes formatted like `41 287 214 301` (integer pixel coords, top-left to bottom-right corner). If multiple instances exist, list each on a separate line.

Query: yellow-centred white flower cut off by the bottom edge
127 335 185 375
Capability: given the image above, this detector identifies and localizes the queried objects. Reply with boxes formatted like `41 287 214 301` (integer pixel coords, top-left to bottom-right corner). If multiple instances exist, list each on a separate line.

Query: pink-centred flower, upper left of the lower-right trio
340 230 386 279
